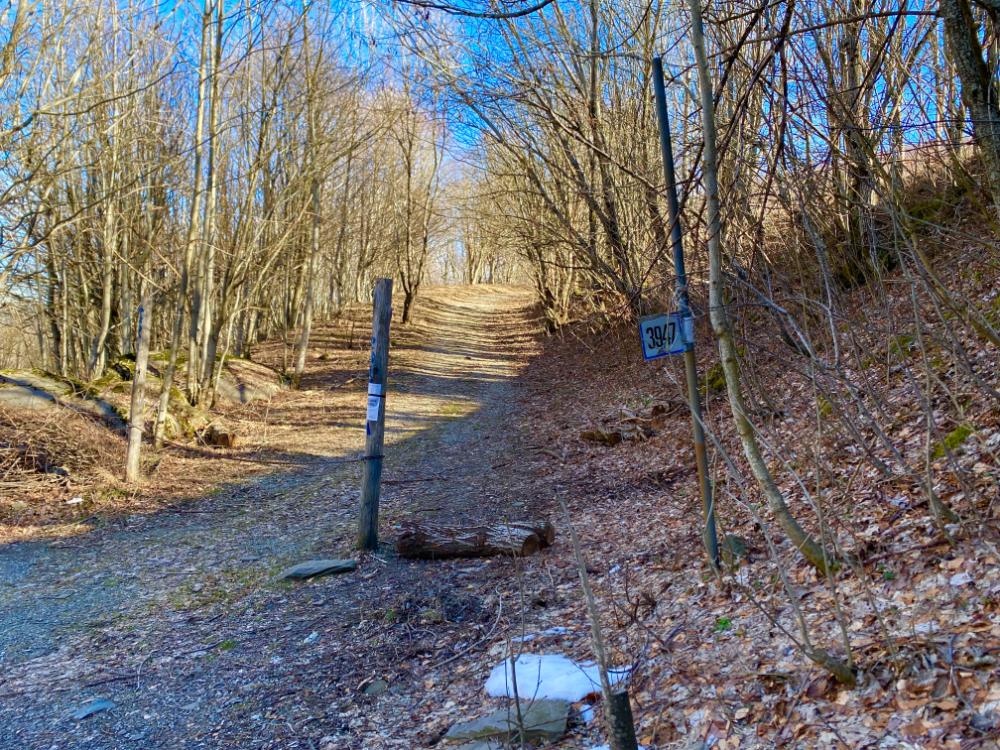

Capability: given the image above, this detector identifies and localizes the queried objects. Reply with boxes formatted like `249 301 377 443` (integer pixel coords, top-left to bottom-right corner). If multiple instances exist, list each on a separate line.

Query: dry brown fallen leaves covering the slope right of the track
438 245 1000 750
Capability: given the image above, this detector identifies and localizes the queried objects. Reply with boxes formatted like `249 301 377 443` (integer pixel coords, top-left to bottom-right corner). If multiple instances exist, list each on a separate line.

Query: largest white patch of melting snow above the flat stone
486 654 631 703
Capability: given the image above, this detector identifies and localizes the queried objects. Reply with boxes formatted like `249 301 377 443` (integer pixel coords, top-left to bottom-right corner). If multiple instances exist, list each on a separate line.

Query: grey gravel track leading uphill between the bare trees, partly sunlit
0 288 534 750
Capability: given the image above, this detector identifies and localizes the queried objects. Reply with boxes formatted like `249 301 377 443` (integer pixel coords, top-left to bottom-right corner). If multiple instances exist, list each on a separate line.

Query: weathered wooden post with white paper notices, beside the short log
358 279 392 550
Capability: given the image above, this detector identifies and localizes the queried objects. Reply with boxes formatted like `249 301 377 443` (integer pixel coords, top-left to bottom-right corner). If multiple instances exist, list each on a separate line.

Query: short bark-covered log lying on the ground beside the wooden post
396 520 556 560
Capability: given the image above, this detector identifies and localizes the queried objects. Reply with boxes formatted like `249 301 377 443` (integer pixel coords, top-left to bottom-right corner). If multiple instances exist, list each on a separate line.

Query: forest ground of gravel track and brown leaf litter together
0 287 1000 750
